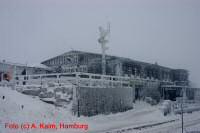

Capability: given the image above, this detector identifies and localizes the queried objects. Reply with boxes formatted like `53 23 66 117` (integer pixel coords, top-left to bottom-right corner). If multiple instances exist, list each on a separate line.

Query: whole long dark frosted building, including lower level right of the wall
41 50 189 100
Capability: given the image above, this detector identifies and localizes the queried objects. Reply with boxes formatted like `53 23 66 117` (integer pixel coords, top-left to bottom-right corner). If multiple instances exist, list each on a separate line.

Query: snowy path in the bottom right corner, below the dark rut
104 109 200 133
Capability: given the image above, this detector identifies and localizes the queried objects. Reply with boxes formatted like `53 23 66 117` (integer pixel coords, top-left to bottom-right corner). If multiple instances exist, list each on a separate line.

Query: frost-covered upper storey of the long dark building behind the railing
41 50 189 83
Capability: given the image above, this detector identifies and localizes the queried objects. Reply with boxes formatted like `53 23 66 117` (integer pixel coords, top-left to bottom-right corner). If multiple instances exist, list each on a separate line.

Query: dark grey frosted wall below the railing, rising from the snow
73 87 134 116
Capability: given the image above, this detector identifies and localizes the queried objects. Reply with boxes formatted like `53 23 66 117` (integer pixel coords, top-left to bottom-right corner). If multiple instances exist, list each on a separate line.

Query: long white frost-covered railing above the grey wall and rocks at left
13 72 130 87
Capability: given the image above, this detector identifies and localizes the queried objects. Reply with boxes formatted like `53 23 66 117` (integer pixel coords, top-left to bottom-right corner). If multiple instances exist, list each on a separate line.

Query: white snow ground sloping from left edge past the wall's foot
0 87 200 133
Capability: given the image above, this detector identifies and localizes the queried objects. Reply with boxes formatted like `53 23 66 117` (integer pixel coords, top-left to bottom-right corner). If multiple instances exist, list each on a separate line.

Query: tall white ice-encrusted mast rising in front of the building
98 23 110 75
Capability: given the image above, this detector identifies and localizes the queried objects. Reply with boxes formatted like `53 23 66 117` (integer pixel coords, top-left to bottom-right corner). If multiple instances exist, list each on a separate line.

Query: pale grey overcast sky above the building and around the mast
0 0 200 87
